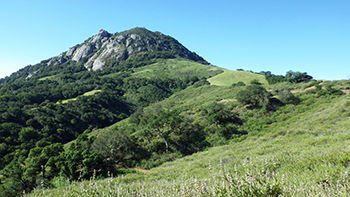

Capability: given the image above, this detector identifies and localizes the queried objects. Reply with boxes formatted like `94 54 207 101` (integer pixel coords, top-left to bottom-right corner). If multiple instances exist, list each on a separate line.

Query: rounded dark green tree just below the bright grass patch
236 85 272 108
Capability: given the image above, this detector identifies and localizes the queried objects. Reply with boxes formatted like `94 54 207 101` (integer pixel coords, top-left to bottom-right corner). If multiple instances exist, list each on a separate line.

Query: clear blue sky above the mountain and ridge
0 0 350 80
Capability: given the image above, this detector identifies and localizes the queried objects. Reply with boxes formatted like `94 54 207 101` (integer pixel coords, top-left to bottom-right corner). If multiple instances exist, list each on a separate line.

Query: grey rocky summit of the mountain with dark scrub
47 27 205 70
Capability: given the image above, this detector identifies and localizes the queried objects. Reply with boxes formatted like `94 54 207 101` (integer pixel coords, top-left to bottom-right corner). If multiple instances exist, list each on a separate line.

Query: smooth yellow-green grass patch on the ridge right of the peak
208 70 268 86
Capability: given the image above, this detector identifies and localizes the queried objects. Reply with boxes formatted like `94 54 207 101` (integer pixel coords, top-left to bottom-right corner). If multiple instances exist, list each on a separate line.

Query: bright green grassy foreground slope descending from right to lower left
30 95 350 196
